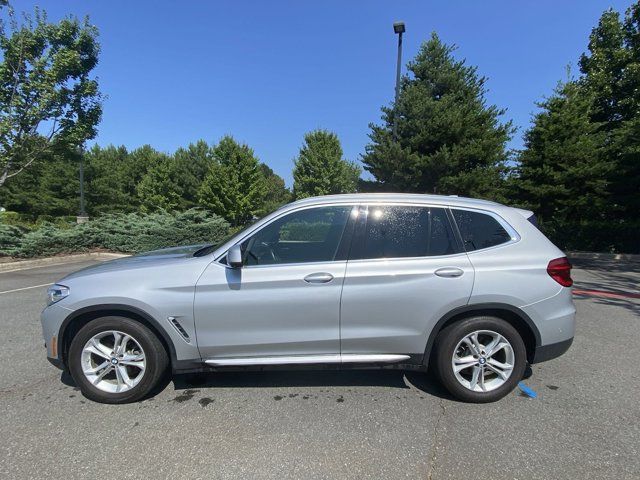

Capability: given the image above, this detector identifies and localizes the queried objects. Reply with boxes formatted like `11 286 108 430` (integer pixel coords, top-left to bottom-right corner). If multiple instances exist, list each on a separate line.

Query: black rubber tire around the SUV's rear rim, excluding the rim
434 316 527 403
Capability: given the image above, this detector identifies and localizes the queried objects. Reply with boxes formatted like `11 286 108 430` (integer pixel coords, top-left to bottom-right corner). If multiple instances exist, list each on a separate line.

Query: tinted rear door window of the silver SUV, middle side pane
352 205 457 259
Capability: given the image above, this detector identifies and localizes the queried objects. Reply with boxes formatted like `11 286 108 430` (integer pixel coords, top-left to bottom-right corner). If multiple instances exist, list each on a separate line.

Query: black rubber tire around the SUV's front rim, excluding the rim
67 317 169 404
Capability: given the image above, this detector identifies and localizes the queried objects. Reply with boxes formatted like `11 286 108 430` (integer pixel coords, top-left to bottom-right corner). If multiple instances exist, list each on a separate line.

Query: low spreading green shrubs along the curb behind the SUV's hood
0 209 229 257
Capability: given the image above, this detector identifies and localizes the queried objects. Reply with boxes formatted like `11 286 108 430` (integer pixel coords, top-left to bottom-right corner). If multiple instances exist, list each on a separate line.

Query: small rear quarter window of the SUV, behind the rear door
451 209 511 252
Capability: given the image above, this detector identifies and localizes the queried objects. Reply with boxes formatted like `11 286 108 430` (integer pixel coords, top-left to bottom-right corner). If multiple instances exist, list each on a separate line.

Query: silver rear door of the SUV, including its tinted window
340 204 474 358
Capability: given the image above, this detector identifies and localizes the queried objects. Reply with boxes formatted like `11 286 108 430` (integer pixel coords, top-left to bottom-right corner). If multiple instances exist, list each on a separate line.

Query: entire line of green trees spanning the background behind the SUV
0 3 640 252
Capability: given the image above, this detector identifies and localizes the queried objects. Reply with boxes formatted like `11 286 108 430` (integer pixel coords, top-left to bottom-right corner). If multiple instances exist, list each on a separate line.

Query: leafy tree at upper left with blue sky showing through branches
0 8 102 187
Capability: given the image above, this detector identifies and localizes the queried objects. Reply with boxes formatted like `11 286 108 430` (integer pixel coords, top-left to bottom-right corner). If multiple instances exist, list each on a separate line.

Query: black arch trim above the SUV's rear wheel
422 303 541 366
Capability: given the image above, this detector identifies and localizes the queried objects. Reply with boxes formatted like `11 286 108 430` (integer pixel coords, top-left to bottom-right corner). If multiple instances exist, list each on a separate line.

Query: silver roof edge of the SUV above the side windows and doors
288 193 504 207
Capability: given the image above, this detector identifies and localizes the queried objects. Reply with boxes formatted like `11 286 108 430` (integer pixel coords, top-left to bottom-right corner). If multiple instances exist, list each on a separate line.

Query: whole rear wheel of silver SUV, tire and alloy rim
435 317 527 403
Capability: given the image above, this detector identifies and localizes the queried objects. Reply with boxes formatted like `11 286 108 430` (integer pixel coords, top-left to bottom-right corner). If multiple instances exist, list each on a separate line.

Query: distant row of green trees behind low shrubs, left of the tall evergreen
0 130 360 226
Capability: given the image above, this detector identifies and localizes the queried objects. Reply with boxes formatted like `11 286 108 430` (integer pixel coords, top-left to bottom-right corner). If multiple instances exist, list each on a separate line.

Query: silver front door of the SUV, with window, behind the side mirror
194 205 355 360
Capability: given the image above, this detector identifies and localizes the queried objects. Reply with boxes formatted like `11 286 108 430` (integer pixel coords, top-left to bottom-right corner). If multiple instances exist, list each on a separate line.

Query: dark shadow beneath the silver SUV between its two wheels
173 370 454 400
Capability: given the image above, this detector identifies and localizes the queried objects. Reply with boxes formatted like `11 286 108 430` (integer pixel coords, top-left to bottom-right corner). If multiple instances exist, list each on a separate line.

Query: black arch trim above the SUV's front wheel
58 304 177 368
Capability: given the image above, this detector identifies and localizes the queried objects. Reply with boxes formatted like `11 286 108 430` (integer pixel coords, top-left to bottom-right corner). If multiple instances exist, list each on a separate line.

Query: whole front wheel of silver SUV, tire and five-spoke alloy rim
68 317 169 403
